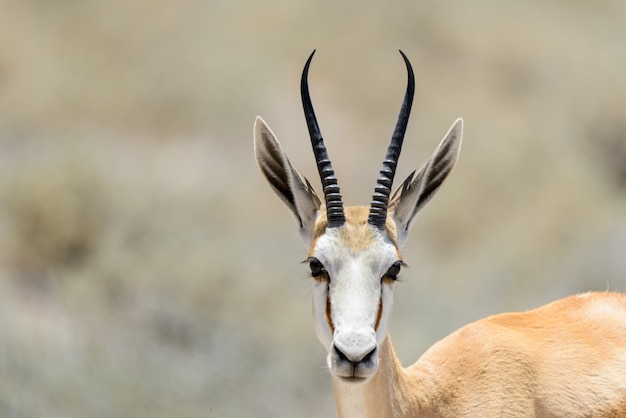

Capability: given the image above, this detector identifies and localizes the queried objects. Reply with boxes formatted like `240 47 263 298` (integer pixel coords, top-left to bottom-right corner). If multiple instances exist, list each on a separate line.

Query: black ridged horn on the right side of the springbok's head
367 51 415 230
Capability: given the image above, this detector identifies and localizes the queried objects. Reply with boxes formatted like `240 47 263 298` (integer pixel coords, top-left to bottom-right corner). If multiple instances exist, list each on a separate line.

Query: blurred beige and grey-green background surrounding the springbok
0 0 626 418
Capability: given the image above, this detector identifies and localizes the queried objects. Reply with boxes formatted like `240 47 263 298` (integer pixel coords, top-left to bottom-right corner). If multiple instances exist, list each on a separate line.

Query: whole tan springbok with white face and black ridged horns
254 51 626 418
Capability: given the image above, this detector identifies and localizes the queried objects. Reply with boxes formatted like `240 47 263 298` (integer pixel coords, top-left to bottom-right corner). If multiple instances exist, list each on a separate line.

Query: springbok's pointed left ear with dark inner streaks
254 116 322 244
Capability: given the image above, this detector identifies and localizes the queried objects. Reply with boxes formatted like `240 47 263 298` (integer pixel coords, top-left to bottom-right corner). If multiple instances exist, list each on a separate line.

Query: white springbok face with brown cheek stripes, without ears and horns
308 207 402 382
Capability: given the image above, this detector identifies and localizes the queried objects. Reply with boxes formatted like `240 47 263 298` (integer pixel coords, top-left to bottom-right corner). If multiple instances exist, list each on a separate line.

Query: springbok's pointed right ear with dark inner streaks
389 118 463 245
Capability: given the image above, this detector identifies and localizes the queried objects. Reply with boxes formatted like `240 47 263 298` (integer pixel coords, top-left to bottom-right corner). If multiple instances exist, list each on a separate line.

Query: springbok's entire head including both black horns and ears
254 51 463 382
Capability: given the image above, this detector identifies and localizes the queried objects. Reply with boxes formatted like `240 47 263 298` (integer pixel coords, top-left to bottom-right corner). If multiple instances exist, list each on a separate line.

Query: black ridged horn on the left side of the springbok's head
300 50 346 228
